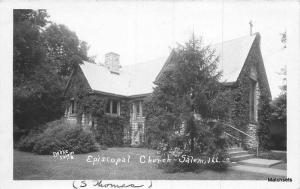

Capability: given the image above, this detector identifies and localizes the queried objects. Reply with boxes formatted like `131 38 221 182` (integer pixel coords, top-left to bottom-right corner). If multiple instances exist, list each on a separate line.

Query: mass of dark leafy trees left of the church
13 9 88 136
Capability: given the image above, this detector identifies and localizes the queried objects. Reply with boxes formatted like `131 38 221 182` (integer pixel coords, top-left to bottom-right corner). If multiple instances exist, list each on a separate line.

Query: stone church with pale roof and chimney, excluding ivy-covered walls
64 33 271 147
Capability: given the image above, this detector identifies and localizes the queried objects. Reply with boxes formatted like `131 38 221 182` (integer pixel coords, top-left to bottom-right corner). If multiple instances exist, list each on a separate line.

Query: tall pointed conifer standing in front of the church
146 36 221 153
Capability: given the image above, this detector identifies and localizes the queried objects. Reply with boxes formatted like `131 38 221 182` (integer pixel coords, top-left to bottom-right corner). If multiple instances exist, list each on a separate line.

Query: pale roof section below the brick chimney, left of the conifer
80 57 167 96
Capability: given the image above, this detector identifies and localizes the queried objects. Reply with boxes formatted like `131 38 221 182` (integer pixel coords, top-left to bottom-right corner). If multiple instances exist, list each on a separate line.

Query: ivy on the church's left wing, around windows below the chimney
64 69 129 146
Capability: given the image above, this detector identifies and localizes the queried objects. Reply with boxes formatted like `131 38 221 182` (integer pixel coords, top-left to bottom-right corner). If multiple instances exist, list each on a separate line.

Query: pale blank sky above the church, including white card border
48 1 300 98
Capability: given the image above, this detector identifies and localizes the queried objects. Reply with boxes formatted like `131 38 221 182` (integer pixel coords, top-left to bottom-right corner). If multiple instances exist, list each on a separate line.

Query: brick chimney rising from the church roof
105 52 121 74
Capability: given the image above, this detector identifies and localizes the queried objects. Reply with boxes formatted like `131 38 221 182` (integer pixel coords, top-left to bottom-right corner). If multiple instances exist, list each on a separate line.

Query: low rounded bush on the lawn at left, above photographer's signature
18 122 99 154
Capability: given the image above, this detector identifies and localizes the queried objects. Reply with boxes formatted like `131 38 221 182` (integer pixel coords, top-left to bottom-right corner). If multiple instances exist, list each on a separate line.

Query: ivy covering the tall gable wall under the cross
211 37 271 149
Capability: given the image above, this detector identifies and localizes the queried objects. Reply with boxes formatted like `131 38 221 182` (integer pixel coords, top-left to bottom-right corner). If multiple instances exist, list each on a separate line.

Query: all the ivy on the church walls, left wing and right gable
64 36 270 148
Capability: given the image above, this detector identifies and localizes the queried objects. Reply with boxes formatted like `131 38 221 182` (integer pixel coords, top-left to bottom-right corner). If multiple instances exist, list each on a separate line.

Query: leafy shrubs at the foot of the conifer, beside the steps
159 122 228 173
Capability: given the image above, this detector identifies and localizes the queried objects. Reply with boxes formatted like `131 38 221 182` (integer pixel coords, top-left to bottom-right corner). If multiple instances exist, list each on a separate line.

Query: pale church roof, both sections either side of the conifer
80 35 255 96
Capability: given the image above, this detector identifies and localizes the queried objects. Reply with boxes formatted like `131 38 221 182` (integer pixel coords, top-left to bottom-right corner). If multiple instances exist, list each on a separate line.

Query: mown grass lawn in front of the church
14 148 278 180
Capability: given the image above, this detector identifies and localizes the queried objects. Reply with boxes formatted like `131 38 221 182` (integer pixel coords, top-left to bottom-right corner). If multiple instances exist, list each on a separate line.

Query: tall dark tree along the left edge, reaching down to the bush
13 9 54 132
